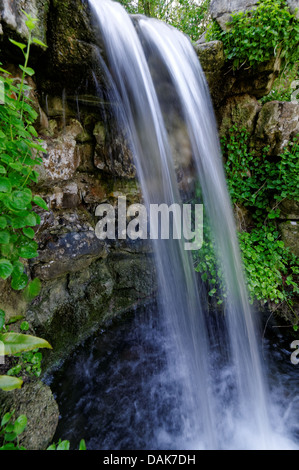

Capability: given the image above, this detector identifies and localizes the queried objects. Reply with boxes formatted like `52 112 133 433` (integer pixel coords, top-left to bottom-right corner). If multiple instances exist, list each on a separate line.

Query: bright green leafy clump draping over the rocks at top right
207 0 299 69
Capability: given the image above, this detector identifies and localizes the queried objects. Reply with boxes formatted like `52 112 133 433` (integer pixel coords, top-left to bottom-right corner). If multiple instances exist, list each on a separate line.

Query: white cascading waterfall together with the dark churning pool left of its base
47 0 296 449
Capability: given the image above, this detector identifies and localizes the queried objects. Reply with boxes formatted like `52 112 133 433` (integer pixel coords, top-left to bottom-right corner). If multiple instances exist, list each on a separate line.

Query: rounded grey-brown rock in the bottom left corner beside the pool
0 381 59 450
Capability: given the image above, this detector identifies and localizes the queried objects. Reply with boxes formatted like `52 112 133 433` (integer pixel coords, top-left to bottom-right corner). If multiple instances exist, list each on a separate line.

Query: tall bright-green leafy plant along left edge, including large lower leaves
0 12 51 391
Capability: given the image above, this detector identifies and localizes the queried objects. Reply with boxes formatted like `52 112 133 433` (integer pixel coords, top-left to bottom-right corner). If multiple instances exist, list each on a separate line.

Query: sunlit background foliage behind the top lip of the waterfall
119 0 210 41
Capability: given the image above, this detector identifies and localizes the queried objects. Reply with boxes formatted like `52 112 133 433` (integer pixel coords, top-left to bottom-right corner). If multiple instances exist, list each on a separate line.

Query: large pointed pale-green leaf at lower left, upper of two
0 333 52 355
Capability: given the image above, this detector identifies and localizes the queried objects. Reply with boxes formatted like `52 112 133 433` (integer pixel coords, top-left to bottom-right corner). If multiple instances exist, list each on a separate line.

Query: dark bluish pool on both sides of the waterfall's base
46 309 299 450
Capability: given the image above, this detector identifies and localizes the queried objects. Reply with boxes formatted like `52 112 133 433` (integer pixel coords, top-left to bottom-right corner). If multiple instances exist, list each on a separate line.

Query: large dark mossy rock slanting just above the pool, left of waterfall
26 251 156 370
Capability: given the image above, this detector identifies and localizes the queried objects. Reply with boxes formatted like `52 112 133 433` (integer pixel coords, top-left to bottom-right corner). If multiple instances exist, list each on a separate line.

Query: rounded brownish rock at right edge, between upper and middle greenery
254 101 299 155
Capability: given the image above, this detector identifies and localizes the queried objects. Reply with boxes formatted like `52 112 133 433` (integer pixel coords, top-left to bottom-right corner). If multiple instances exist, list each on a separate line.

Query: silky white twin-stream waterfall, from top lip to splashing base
90 0 295 449
